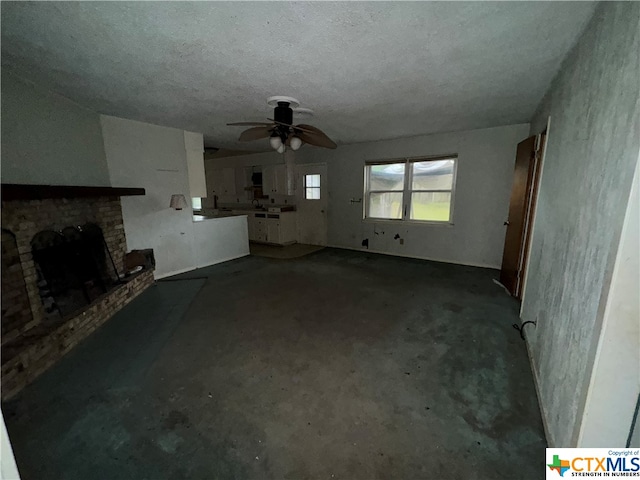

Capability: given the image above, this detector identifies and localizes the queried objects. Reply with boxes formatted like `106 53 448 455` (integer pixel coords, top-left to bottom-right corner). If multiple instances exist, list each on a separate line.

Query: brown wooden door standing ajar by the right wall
500 135 540 298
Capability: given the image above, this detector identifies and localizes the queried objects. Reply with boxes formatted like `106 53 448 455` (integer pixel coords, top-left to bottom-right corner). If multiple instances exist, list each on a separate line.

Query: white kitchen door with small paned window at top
296 163 327 245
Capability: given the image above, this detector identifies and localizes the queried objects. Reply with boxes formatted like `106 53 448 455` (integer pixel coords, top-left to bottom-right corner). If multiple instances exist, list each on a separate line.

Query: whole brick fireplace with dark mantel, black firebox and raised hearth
2 185 153 400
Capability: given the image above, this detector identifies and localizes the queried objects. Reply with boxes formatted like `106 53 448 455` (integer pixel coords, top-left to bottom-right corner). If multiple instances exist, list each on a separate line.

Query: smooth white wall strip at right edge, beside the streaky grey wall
578 158 640 447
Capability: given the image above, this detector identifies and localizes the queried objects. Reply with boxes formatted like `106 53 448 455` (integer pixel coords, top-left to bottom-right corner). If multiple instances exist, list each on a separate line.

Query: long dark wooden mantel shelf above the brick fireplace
2 183 145 200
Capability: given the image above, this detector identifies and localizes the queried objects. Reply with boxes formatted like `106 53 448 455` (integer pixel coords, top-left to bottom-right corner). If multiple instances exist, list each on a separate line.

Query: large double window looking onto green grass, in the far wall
364 157 457 223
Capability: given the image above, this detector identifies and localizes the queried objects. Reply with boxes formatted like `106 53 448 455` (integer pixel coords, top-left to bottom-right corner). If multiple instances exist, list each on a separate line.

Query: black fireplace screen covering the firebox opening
31 223 118 317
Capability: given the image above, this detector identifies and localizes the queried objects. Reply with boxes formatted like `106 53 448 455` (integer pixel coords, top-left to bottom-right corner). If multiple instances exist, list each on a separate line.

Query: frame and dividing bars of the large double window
362 154 458 225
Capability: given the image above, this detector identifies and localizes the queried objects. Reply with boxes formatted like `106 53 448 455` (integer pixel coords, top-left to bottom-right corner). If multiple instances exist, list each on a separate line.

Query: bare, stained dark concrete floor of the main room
3 249 545 480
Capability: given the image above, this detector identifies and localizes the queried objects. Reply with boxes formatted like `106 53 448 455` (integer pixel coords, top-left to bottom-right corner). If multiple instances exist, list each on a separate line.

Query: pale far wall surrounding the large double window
207 124 529 268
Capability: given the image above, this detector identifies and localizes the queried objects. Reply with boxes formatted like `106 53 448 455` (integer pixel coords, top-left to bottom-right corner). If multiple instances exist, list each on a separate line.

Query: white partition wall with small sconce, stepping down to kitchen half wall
101 115 249 278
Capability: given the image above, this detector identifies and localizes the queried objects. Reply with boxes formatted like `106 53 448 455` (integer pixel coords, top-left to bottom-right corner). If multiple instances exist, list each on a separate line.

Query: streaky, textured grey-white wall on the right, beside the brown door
522 2 640 447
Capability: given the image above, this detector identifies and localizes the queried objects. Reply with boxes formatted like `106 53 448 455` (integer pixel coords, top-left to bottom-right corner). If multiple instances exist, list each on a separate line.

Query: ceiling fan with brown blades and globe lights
227 96 337 153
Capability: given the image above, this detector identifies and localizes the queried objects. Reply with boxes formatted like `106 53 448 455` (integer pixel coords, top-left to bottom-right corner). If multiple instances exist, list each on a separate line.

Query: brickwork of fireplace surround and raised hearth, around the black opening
2 196 153 399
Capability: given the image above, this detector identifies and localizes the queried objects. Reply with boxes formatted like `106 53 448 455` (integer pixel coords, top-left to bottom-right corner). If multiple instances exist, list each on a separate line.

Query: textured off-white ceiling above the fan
2 2 595 149
